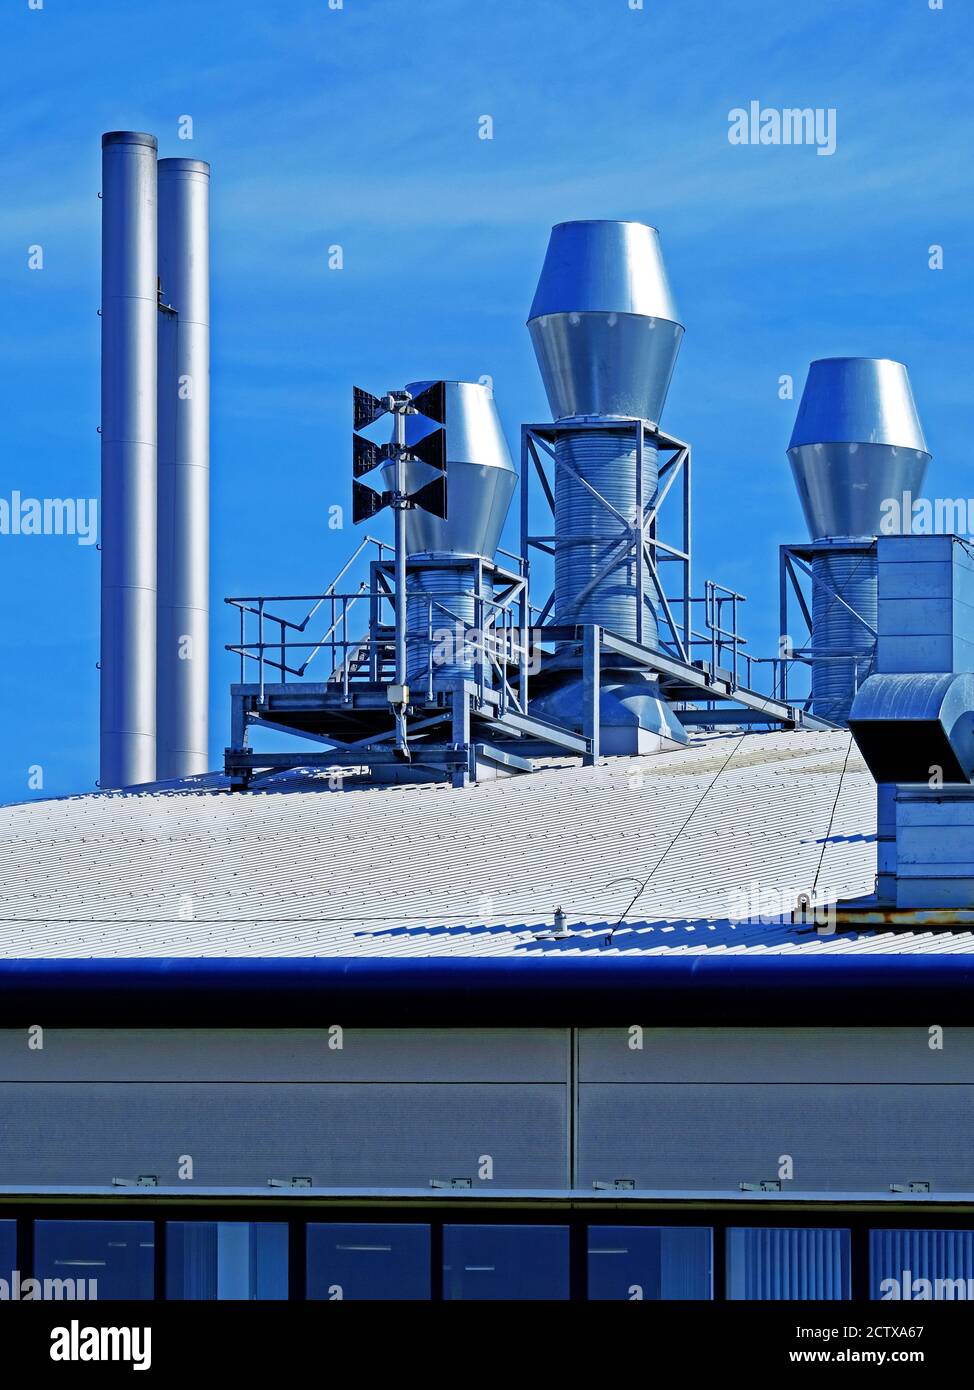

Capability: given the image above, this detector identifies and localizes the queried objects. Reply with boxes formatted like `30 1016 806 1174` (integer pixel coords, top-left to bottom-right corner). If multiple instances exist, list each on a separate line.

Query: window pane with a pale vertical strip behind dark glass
165 1220 288 1300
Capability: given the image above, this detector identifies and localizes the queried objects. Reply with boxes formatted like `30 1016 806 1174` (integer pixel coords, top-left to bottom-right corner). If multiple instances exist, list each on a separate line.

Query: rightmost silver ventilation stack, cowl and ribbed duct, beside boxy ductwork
788 357 931 724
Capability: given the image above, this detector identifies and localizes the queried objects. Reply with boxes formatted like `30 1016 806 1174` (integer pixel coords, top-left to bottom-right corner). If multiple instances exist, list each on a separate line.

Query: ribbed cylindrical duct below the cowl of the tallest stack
554 427 659 646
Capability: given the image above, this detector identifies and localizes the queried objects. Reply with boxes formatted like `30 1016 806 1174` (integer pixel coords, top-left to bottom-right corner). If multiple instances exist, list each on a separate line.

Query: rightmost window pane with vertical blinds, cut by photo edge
870 1230 974 1302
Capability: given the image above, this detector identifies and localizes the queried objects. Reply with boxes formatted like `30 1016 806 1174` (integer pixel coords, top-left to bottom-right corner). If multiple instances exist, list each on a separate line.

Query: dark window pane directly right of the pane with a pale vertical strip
307 1222 429 1300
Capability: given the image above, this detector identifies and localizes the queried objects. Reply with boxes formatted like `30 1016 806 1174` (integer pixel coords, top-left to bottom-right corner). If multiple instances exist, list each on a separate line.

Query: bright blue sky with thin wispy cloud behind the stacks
0 0 974 801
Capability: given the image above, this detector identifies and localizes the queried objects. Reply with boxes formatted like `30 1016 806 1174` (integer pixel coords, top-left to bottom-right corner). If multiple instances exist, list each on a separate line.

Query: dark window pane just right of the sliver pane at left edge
33 1220 156 1302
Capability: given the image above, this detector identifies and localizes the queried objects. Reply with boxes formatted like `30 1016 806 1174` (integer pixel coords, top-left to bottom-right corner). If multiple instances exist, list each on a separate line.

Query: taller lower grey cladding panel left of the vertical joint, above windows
0 1081 568 1194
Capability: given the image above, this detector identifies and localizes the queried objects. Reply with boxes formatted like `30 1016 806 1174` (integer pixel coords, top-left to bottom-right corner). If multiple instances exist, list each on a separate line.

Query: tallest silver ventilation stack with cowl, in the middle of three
528 221 686 753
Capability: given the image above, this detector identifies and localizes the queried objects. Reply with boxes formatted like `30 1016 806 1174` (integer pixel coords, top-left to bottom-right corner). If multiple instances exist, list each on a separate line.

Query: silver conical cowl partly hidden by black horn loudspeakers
382 381 517 559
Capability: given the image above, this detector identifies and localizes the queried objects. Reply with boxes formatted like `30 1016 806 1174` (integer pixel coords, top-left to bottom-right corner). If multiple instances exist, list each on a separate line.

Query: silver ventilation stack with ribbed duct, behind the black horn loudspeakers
383 381 517 691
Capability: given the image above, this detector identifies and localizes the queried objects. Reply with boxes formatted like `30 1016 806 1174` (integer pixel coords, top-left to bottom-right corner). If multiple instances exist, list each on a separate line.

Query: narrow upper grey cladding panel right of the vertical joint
578 1026 974 1084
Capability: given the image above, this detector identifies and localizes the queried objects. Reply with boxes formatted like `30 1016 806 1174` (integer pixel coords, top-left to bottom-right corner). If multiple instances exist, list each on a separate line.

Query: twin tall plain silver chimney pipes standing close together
99 131 210 788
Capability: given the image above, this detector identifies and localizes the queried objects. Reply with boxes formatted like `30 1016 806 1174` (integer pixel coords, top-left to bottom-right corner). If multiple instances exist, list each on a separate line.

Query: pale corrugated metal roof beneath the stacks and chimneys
0 731 974 958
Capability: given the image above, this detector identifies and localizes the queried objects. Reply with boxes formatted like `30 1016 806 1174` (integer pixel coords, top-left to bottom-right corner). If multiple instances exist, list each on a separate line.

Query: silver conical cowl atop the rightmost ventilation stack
788 357 931 541
